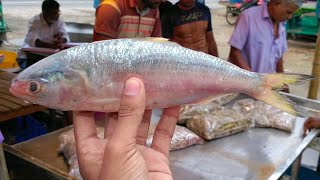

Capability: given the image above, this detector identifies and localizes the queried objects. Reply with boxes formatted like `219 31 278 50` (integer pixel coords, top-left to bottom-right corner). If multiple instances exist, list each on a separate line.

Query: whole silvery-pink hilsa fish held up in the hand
10 38 310 115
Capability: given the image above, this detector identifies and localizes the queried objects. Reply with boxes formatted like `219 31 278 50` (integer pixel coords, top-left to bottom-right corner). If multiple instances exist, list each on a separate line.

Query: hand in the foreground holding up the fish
74 78 179 179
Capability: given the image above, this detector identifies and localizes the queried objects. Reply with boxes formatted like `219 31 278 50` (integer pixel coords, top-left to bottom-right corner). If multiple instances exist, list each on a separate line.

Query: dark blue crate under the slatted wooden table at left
15 116 48 143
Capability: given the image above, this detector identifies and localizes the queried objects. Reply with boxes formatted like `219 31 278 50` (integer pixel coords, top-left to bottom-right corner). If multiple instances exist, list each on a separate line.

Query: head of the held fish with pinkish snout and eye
10 59 86 110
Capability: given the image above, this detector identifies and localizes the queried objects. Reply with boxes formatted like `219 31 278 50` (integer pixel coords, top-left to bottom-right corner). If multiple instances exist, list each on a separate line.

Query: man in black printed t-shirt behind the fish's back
161 0 218 57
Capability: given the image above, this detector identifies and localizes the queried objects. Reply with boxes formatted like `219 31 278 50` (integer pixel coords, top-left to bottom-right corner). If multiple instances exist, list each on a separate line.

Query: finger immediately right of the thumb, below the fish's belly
136 110 152 145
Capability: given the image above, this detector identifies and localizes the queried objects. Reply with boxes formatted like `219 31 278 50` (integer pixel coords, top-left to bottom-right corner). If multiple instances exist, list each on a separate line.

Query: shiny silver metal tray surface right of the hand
170 93 320 180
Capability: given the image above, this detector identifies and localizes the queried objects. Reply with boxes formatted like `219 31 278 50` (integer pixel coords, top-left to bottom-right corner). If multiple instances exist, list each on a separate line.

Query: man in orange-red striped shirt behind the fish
93 0 162 41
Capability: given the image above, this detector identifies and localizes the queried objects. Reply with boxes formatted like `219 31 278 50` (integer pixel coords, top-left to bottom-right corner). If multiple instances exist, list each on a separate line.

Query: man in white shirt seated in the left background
18 0 69 68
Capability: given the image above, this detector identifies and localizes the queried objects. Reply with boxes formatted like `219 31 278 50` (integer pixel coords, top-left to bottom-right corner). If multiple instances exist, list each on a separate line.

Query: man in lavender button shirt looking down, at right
229 0 302 73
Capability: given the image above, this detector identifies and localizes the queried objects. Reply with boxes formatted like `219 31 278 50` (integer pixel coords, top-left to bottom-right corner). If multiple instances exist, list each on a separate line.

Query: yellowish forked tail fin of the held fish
253 73 313 116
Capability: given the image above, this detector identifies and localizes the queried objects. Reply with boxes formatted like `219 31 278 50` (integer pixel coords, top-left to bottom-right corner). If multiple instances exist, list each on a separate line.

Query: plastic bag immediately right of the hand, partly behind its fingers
146 125 204 151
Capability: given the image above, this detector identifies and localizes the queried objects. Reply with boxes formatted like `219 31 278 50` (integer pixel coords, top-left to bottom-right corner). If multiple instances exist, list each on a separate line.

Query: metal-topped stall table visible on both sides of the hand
4 95 320 180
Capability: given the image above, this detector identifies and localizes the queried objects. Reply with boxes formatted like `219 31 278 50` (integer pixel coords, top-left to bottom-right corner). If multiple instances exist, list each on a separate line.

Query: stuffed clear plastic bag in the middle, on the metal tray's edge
187 109 252 140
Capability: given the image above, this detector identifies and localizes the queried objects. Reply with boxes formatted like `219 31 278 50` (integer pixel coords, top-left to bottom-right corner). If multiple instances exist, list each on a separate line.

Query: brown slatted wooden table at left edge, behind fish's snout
0 71 47 122
